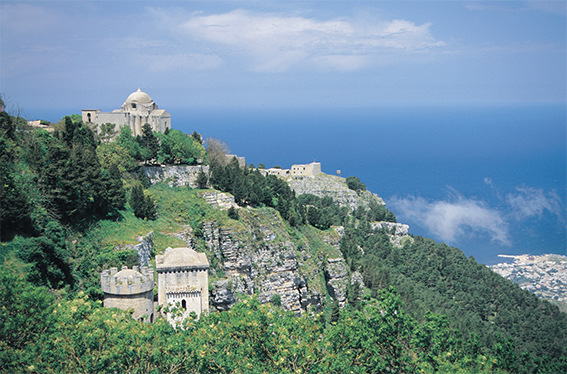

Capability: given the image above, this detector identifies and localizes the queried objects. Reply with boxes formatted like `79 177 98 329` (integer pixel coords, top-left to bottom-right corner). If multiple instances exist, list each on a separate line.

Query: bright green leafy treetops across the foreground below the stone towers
0 268 502 373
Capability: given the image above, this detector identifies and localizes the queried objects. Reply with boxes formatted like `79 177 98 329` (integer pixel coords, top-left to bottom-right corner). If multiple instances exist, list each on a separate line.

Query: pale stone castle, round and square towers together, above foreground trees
100 248 209 323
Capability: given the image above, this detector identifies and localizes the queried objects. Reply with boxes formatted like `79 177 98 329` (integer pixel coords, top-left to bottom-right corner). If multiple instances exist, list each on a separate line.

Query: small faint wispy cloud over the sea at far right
506 186 563 220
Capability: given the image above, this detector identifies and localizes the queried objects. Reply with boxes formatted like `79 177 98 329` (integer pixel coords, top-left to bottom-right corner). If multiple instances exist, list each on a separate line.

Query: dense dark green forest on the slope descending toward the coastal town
341 222 567 373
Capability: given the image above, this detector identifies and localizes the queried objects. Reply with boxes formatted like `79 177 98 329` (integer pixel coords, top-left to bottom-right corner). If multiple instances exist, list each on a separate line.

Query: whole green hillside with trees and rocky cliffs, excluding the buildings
0 113 567 373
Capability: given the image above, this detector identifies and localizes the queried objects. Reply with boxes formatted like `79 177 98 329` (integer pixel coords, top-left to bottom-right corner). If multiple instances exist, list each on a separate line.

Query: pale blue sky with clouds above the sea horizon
0 0 567 112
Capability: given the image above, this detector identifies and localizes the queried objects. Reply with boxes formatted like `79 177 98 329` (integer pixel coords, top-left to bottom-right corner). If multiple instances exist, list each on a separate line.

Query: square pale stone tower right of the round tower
156 248 209 323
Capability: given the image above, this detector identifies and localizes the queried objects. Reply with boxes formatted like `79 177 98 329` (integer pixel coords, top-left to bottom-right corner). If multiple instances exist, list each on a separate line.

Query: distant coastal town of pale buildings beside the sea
489 254 567 310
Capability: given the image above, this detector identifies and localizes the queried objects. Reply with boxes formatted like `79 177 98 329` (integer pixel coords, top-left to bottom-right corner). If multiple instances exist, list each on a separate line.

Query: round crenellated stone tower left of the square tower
100 266 154 323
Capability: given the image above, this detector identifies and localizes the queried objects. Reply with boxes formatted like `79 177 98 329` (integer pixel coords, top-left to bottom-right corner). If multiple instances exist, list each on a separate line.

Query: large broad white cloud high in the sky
177 10 445 71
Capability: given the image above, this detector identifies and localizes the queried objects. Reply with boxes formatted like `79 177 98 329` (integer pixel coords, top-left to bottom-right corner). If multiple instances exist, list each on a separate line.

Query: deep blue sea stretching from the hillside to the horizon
32 105 567 264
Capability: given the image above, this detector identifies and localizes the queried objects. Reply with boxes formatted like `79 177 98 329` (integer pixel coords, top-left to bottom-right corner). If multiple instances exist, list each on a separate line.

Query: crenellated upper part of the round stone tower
100 266 154 295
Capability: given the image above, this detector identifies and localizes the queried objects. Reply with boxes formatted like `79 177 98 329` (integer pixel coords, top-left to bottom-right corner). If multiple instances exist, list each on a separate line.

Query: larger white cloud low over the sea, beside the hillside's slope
388 192 511 246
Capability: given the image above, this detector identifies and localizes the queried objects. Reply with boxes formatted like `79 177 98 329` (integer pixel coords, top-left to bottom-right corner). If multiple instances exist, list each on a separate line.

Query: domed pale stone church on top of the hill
81 88 171 136
